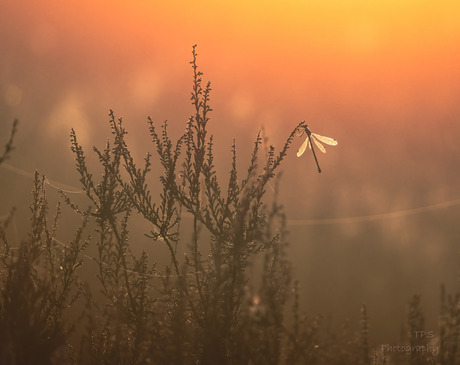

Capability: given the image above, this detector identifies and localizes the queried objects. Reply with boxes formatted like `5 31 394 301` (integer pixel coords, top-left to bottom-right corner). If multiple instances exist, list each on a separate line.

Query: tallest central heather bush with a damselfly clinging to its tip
64 48 302 364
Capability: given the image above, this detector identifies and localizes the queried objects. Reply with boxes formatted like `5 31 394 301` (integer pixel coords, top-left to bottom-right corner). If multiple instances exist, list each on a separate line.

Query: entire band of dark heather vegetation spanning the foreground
0 49 460 365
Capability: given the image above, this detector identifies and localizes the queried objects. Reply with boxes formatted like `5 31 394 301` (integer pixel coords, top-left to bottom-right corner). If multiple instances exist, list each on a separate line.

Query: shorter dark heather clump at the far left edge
0 123 88 365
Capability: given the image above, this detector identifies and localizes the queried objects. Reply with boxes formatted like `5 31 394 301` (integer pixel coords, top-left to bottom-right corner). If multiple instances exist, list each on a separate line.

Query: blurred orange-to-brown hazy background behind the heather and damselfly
0 1 460 344
